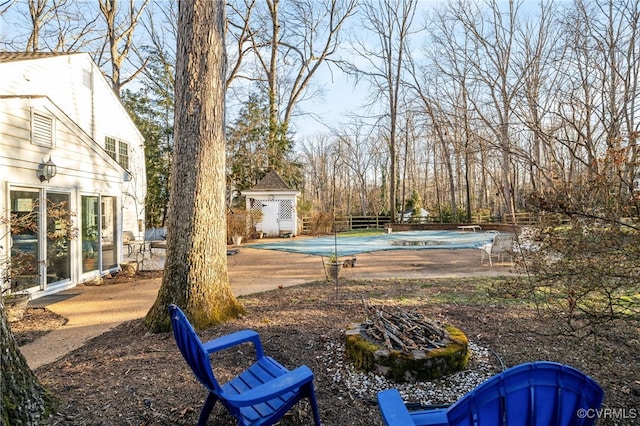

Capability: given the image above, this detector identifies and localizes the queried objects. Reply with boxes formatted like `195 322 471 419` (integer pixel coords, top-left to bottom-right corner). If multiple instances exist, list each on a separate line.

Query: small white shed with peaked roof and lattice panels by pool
242 170 300 237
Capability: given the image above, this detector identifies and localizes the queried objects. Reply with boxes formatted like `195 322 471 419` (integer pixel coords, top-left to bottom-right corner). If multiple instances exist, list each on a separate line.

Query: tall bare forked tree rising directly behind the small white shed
228 0 356 169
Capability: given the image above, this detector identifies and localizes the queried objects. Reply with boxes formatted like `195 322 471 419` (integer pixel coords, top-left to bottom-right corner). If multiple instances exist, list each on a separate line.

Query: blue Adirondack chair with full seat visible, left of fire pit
169 305 320 426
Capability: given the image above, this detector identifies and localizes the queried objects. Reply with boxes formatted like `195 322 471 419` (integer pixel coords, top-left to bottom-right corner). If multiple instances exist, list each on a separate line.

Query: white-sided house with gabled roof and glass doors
0 52 146 297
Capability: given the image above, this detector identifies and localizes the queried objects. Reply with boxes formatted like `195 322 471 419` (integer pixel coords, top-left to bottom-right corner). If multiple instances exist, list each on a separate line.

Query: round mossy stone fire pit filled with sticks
345 303 470 382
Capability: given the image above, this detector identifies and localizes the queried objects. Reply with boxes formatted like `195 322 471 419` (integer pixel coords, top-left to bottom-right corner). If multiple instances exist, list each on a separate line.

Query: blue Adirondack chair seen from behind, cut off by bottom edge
378 361 604 426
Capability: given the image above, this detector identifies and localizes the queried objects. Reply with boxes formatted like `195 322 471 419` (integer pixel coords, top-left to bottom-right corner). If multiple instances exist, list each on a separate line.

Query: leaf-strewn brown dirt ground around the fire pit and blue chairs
12 277 640 425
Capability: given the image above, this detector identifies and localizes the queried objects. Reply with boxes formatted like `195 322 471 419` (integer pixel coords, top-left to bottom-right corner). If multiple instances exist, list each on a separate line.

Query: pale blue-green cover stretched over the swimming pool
247 231 491 257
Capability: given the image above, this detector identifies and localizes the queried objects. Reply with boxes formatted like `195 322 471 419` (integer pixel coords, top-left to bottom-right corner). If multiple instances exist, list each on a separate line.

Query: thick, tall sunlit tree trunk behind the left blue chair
145 0 243 332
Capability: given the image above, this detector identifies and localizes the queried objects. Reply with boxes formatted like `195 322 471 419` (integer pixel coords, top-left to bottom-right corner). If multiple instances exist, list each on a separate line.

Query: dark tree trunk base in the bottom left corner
0 297 55 425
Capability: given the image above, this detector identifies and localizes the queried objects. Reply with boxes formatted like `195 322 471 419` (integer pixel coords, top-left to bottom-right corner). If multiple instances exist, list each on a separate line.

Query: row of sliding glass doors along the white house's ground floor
9 188 119 290
